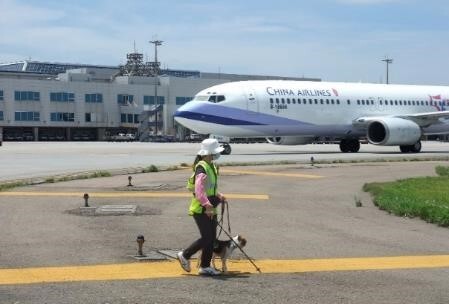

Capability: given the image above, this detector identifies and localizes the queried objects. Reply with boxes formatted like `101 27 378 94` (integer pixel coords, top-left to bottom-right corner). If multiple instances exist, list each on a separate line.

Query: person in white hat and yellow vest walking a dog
177 138 227 276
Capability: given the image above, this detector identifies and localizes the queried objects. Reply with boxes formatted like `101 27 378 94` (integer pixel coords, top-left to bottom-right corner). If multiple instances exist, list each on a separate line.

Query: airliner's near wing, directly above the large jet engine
352 111 449 128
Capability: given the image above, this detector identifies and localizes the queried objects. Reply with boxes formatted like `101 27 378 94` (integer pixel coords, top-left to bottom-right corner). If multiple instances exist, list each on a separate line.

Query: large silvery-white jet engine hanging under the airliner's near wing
367 117 422 146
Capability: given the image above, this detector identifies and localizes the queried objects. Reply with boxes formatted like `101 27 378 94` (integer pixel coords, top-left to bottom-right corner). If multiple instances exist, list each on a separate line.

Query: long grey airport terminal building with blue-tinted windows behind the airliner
0 52 320 141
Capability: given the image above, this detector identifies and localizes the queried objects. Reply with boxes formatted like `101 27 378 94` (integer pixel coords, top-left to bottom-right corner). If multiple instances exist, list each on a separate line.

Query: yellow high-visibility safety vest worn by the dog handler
187 160 218 215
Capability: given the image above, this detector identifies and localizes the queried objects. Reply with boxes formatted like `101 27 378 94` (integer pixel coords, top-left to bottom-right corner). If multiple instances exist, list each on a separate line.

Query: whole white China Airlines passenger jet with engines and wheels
174 80 449 154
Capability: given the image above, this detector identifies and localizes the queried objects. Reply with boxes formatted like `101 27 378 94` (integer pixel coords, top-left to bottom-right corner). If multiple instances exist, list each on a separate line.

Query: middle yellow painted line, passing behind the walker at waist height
0 191 270 200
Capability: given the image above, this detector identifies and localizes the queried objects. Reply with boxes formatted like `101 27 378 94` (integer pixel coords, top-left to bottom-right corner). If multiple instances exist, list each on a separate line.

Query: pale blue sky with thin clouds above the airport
0 0 449 85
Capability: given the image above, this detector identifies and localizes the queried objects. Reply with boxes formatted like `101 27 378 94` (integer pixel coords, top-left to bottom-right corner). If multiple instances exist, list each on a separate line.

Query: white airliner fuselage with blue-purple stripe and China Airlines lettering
175 80 449 137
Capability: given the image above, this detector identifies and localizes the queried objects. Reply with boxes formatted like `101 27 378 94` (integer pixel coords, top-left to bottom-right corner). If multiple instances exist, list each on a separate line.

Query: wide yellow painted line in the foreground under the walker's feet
0 255 449 285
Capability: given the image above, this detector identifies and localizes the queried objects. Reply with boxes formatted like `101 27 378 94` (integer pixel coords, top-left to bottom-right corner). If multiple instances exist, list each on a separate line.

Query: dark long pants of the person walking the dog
183 213 217 267
